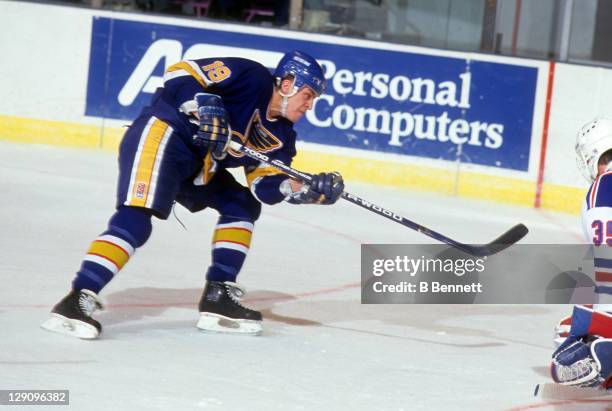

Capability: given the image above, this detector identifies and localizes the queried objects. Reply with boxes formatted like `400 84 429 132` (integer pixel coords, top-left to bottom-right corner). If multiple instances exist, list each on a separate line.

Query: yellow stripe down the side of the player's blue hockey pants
129 119 168 207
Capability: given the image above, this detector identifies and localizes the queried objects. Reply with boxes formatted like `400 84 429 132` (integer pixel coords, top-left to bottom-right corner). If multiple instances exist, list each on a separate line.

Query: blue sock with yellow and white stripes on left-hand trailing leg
72 207 152 293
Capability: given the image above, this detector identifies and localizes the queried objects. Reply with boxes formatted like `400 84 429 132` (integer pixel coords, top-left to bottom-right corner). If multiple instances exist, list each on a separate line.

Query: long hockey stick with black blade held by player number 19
229 141 529 257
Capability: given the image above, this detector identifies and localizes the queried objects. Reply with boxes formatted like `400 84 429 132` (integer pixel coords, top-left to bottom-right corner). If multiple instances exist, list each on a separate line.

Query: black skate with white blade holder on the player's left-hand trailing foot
41 290 104 339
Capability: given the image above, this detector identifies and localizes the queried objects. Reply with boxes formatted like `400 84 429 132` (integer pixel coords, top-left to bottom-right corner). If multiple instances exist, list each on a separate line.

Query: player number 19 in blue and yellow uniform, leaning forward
42 51 344 339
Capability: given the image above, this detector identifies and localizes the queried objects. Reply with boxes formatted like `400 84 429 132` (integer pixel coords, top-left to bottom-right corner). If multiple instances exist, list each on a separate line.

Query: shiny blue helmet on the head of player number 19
274 50 326 96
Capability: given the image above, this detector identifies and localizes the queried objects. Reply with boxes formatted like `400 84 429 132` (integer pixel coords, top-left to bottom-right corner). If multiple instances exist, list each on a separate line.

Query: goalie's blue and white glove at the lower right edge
550 335 612 389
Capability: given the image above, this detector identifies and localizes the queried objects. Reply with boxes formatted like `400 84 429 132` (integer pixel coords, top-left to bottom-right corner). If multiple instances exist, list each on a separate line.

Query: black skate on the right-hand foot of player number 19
197 281 262 335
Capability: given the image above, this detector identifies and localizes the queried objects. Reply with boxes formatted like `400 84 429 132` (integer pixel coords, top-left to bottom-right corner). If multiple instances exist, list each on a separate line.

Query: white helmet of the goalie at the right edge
576 117 612 182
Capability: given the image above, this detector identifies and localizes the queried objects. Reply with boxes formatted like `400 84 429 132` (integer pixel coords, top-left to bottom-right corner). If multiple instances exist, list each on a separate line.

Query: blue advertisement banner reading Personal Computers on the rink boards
85 17 538 171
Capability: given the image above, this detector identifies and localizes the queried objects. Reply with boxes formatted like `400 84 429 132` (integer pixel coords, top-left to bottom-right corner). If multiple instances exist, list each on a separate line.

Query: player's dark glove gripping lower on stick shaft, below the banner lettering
281 171 344 204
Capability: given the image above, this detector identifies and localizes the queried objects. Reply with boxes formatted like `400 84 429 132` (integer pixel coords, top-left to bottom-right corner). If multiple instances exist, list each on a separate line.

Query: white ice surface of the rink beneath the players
0 143 612 411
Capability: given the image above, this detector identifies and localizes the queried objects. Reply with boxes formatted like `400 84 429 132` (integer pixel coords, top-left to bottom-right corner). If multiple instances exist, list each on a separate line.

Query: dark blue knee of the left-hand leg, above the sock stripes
108 207 153 248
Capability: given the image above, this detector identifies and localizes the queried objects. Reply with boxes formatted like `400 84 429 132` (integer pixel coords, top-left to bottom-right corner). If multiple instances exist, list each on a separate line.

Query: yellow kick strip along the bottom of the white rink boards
0 116 586 214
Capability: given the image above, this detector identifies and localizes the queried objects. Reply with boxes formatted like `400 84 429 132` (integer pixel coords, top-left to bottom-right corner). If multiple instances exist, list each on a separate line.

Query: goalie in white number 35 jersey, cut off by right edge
551 118 612 389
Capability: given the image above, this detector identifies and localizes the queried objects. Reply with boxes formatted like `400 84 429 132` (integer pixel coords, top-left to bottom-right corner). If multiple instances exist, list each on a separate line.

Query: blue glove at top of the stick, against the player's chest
193 93 232 160
